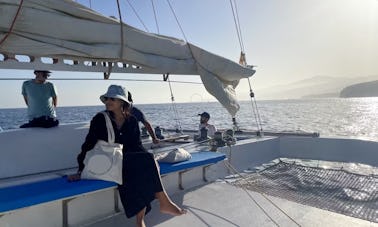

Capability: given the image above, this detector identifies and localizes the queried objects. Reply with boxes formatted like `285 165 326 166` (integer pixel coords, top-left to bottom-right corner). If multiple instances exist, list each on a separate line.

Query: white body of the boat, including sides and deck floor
0 124 378 227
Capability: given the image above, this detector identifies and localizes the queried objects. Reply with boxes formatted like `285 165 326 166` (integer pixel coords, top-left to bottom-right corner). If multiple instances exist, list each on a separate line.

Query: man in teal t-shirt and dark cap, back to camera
20 70 59 128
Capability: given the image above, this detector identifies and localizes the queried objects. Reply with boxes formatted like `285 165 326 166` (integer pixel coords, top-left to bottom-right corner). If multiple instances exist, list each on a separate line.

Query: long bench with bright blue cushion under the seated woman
0 152 226 216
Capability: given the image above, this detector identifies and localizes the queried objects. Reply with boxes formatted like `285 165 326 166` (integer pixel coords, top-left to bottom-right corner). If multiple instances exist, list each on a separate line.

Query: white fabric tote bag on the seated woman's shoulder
81 112 123 184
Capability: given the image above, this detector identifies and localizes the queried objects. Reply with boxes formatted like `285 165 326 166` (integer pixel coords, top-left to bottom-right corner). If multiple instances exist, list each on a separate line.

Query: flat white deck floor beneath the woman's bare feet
86 181 378 227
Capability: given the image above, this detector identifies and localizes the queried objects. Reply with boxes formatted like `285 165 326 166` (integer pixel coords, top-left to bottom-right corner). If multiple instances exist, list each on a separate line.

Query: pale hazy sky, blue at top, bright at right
0 0 378 108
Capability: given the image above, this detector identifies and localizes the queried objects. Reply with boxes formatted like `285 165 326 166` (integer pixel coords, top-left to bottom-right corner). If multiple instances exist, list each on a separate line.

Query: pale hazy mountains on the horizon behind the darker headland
251 75 378 100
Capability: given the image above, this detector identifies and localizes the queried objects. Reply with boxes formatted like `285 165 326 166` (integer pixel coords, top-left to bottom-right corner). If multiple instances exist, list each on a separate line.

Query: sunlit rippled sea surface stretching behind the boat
0 98 378 140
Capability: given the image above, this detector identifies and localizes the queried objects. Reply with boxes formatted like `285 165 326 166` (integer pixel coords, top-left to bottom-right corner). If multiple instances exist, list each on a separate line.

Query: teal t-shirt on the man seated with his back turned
22 80 57 120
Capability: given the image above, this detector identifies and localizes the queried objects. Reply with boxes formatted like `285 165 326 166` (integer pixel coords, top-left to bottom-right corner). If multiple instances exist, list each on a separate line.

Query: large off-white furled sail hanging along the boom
0 0 255 116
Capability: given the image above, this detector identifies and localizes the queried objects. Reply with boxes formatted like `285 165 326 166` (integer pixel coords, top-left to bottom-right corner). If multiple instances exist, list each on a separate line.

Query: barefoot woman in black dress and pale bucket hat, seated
69 85 186 226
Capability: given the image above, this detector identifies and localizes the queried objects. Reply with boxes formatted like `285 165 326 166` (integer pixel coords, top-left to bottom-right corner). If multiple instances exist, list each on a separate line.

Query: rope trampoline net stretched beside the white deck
232 160 378 223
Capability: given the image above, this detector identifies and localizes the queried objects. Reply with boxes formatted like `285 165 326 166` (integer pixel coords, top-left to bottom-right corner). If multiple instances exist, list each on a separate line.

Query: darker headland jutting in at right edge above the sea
340 80 378 98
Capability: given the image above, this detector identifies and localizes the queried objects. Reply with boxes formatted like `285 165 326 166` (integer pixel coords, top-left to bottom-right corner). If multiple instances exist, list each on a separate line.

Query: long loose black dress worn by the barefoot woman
77 113 163 218
